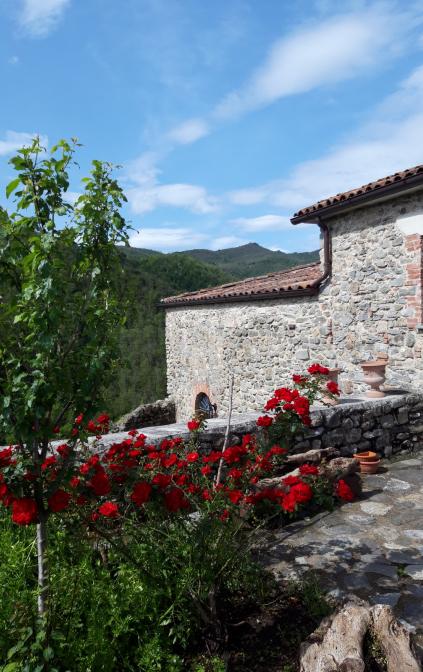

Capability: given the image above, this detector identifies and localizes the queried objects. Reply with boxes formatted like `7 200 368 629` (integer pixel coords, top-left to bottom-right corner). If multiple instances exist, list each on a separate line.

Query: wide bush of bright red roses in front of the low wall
0 364 353 527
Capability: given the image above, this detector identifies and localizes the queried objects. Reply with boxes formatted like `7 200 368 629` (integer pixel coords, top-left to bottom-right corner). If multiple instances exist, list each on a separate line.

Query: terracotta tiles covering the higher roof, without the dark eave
291 164 423 223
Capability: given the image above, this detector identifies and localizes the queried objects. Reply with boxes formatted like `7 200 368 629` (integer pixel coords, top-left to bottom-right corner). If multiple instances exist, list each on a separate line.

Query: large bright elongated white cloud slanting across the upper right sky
217 5 413 120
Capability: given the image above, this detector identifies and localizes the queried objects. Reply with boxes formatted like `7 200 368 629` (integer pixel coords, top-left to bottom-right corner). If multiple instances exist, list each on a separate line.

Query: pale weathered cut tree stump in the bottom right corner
300 598 422 672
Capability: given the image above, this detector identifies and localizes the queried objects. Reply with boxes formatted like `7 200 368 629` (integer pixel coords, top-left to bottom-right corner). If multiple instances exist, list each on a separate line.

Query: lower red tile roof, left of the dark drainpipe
161 262 322 307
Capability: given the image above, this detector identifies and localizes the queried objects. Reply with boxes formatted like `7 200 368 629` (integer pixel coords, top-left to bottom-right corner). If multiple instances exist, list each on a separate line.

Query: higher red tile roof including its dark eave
291 164 423 224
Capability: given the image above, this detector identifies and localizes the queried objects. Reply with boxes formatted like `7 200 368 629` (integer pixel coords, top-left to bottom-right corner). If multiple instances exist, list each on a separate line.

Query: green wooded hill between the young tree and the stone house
105 243 318 418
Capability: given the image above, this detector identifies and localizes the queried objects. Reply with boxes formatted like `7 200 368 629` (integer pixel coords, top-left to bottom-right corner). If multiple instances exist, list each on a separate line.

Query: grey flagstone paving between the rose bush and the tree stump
262 456 423 651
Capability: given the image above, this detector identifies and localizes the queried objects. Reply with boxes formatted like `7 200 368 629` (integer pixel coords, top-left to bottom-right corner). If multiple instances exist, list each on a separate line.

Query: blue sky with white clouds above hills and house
0 0 423 251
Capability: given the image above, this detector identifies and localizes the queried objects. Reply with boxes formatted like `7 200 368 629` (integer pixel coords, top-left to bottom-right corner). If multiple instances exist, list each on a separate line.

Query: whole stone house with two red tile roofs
162 165 423 420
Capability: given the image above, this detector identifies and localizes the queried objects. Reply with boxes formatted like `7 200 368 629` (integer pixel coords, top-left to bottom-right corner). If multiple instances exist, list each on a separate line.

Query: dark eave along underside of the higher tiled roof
291 173 423 224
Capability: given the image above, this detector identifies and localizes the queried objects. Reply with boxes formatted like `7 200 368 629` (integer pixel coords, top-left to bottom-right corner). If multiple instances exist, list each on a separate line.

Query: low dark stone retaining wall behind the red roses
102 392 423 457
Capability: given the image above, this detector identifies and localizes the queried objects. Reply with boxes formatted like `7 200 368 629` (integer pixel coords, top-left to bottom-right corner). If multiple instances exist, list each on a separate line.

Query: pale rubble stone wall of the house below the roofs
166 192 423 420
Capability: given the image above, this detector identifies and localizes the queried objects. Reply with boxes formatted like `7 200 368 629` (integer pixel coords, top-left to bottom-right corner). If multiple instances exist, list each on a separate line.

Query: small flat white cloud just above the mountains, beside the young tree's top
129 227 207 252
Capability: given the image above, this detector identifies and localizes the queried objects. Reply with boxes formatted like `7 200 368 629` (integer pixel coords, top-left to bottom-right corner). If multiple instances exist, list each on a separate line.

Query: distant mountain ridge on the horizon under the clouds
121 243 319 280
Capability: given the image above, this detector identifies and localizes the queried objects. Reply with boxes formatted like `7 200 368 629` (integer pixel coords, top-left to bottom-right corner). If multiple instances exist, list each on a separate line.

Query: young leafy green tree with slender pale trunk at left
0 139 127 615
